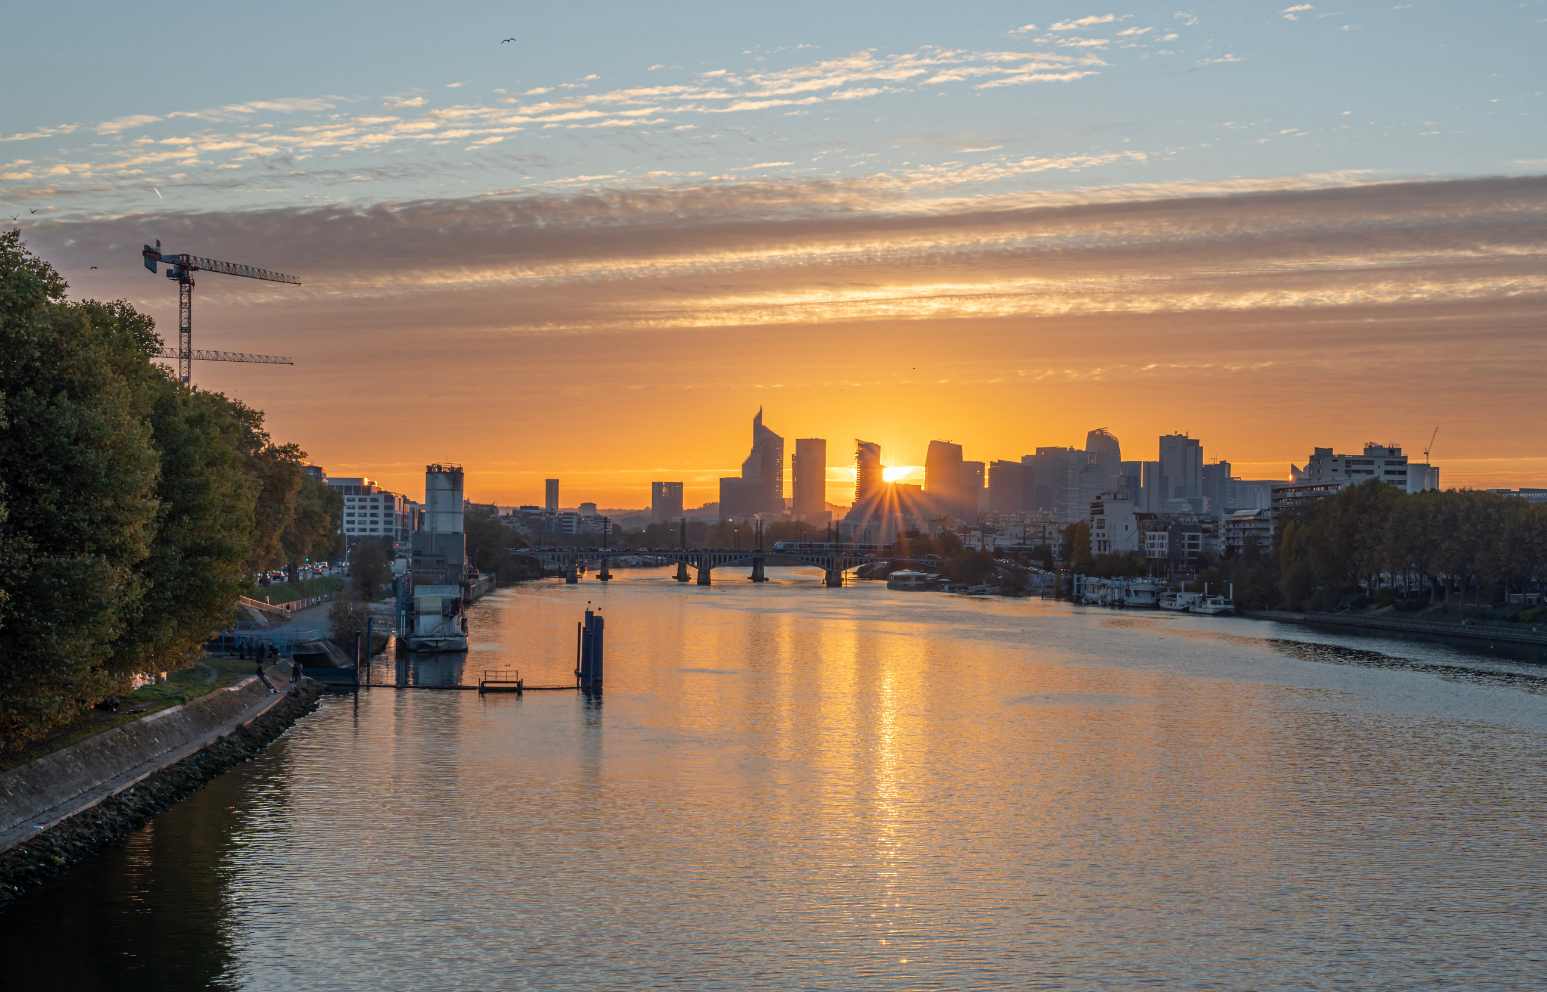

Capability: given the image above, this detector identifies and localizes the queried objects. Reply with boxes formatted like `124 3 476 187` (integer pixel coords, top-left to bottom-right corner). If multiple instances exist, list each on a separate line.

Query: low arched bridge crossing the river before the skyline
517 545 894 588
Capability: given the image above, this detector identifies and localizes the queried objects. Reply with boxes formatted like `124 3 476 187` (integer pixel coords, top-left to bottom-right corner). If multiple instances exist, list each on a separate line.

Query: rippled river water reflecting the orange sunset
0 571 1547 989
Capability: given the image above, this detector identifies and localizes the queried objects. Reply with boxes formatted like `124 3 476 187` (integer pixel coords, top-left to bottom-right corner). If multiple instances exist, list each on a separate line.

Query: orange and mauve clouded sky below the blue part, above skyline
29 171 1547 508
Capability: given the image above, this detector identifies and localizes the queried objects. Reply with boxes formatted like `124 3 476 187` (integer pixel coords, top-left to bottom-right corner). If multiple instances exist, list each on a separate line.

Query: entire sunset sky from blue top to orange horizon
0 0 1547 508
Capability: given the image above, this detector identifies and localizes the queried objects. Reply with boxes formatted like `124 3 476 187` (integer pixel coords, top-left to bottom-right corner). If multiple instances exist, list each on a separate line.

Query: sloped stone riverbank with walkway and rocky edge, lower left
0 678 320 910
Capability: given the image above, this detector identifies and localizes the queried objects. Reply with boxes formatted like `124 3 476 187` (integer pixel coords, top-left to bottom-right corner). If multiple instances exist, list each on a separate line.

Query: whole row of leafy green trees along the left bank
0 232 340 751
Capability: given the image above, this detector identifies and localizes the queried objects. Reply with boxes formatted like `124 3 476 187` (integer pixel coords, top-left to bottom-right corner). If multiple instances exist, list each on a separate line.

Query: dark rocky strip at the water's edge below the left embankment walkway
0 679 322 912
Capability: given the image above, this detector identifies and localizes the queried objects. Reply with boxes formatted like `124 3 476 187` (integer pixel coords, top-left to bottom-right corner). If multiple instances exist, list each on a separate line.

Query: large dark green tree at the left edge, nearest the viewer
0 232 159 744
